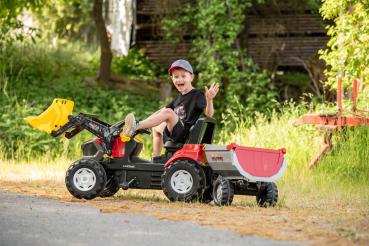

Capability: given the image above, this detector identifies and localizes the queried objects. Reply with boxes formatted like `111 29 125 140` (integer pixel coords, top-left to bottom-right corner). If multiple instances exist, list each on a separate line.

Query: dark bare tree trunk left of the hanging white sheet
93 0 113 84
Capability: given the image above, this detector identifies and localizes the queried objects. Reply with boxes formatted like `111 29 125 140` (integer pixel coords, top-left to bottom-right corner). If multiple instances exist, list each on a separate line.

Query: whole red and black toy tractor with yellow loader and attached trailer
26 99 286 207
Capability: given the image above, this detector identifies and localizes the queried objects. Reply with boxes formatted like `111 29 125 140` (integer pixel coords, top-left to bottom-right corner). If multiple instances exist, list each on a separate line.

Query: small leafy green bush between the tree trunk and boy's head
112 48 165 80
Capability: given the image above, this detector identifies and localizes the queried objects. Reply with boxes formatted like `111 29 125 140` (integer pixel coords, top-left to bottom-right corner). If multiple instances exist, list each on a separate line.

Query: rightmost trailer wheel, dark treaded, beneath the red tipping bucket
256 182 278 208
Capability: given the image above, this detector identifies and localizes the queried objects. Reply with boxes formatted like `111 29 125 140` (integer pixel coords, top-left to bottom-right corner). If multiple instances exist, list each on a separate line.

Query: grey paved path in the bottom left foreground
0 190 296 246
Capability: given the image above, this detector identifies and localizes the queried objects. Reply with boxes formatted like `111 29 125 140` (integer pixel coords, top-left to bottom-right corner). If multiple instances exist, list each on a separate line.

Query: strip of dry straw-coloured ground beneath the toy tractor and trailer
0 180 369 245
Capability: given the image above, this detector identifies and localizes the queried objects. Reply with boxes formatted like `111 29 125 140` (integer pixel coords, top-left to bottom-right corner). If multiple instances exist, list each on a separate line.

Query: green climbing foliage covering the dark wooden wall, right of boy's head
163 0 276 119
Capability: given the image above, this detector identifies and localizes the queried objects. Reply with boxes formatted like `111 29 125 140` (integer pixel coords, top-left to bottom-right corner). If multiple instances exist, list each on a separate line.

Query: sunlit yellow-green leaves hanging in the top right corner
320 0 369 87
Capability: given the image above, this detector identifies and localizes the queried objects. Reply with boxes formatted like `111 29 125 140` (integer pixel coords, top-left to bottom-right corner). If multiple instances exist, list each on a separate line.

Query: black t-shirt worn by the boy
165 89 206 127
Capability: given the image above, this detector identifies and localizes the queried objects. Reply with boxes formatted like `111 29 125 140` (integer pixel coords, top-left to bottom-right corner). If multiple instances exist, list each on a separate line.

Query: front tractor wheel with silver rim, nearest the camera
65 159 106 200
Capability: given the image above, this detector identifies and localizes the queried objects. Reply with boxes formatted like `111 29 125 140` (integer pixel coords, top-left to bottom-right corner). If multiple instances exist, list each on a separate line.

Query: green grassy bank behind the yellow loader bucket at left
0 43 159 159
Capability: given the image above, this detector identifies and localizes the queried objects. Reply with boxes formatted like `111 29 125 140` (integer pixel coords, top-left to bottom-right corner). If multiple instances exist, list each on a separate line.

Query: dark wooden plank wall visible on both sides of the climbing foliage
134 0 328 70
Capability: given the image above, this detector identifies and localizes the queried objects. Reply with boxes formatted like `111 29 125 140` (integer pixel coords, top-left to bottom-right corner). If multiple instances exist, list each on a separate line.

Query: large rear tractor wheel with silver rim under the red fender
161 160 204 202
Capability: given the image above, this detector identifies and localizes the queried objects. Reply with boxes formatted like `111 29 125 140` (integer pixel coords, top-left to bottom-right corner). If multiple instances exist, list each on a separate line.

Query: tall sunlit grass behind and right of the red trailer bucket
219 104 369 207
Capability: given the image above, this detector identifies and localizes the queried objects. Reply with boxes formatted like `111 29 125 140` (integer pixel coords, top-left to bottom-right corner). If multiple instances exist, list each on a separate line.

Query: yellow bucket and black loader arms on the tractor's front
25 98 124 155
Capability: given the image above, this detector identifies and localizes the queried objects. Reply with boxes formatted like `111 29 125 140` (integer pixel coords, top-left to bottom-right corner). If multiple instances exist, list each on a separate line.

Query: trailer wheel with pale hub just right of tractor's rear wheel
213 176 234 206
